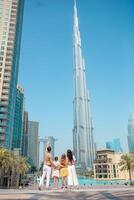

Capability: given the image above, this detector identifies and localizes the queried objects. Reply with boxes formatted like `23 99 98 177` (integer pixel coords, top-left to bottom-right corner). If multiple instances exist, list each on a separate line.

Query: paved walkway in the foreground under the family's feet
0 186 134 200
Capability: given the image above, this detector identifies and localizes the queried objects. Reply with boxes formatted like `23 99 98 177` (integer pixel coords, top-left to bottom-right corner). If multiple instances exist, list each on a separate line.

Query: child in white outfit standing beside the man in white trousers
52 156 60 189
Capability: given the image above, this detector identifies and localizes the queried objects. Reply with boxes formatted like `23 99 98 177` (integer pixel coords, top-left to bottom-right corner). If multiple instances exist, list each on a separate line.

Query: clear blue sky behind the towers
19 0 134 154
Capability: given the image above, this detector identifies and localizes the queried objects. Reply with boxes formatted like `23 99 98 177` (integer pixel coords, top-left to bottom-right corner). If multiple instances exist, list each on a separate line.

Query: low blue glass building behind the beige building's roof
106 138 122 153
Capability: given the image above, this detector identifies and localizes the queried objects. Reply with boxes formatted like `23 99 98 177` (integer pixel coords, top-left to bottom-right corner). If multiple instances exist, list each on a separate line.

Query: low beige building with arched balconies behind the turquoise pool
93 150 134 180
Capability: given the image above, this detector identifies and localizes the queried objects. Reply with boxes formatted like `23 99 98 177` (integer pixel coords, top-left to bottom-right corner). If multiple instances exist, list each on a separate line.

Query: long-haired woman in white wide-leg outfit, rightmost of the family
67 149 79 187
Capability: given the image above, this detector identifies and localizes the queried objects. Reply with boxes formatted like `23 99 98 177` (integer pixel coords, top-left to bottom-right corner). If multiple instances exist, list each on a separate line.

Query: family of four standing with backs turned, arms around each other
39 146 78 190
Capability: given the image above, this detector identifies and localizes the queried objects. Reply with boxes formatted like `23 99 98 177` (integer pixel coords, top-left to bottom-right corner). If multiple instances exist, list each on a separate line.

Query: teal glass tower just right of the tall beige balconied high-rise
12 85 24 149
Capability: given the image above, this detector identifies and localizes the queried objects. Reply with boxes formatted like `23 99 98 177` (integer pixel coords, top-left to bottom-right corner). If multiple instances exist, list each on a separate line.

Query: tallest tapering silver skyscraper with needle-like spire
73 0 95 168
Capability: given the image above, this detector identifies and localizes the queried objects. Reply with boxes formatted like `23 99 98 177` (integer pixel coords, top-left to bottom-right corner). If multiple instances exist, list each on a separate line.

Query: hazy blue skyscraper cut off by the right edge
127 113 134 153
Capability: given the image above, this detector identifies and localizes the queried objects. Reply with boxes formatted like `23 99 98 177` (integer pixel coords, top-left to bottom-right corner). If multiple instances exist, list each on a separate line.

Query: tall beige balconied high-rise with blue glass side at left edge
0 0 24 148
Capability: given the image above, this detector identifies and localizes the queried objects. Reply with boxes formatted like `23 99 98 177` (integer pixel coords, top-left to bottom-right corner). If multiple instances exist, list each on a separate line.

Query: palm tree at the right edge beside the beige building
119 154 134 184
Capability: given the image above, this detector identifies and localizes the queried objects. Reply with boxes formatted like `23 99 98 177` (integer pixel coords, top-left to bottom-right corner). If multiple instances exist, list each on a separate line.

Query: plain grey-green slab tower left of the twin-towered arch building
28 121 39 168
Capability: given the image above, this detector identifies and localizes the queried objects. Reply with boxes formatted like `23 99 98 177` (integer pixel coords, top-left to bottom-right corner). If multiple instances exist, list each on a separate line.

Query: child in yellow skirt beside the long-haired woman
60 154 68 188
